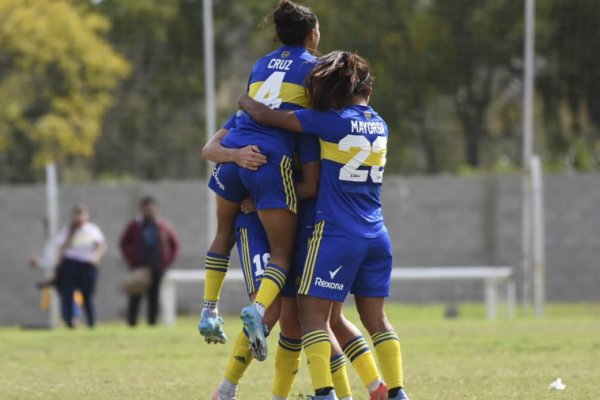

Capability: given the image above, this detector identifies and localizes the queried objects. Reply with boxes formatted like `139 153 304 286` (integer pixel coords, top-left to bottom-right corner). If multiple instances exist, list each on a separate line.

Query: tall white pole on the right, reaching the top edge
521 0 535 308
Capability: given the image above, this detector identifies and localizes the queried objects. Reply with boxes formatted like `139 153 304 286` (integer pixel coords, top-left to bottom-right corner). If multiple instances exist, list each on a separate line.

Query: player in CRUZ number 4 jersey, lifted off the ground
199 0 320 360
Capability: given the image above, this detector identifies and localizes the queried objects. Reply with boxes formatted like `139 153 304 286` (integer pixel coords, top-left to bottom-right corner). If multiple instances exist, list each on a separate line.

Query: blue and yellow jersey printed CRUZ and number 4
222 46 315 157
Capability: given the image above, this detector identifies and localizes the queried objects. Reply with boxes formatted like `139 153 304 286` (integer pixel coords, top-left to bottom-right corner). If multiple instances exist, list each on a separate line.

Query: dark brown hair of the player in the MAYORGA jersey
307 51 374 111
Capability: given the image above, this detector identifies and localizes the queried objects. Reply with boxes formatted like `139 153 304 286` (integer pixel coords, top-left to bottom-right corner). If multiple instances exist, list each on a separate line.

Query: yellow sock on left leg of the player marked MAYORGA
302 329 333 391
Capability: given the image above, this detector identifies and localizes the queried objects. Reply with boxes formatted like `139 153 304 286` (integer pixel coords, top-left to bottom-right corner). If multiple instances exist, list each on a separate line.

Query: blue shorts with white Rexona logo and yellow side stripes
298 221 392 302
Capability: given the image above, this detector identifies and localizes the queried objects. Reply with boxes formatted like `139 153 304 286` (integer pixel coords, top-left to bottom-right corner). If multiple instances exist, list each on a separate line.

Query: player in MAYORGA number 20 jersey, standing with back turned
239 51 408 400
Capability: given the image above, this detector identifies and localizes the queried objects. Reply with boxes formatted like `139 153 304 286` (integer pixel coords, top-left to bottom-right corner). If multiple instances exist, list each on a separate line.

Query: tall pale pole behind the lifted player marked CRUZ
202 0 217 248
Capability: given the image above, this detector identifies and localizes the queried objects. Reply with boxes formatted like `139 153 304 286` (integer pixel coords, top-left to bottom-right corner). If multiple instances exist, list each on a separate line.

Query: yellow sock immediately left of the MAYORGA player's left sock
273 334 302 398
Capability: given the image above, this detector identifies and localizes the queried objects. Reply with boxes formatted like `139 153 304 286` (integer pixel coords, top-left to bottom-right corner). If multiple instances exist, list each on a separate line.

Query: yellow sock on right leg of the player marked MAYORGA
371 331 404 389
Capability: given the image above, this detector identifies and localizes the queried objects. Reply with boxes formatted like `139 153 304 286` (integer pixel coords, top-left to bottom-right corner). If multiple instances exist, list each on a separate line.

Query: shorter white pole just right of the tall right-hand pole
531 155 546 318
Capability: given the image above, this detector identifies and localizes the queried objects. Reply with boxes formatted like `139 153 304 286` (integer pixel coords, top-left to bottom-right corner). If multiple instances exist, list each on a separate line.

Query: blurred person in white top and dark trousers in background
56 204 106 328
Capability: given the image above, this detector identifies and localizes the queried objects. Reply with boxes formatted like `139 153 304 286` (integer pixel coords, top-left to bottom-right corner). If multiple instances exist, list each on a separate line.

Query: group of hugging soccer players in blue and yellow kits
198 0 408 400
